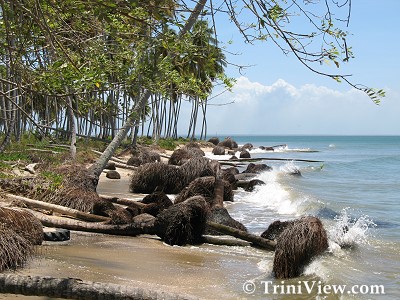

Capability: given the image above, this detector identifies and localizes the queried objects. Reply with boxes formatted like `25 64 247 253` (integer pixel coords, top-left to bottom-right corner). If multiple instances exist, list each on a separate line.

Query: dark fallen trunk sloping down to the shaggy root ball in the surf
207 222 276 251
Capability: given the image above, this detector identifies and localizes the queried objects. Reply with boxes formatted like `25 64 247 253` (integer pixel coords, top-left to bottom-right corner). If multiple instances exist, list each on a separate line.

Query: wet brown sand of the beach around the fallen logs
0 169 272 299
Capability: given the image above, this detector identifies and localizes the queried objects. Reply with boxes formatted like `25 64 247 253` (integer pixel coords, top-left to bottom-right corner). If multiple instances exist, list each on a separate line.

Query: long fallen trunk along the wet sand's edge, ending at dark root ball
29 210 154 236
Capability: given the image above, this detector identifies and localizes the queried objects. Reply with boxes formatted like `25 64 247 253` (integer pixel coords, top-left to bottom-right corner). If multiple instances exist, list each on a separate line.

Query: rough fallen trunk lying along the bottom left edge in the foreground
0 274 197 300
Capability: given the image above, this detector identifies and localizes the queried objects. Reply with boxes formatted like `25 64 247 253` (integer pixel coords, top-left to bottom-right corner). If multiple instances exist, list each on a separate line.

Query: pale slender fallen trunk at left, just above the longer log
6 194 111 222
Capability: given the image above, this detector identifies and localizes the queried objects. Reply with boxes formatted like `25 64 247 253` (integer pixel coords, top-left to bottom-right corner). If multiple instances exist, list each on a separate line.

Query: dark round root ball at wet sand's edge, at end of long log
154 196 208 246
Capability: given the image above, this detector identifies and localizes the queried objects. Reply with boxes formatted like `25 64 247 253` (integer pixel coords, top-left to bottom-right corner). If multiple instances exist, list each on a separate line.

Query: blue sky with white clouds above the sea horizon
183 0 400 137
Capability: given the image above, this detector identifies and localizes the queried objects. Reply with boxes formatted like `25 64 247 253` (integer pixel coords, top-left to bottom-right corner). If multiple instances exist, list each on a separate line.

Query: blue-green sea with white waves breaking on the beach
208 135 400 299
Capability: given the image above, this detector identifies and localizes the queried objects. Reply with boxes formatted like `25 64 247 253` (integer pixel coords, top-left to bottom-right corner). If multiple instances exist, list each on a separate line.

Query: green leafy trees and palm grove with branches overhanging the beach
0 0 384 166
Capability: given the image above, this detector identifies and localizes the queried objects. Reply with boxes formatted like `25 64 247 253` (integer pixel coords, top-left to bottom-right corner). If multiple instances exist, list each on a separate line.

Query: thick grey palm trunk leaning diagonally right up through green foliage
89 0 207 177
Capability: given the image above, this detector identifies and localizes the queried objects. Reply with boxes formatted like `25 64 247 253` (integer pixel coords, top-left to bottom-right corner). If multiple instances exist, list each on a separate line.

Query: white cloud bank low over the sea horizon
203 77 400 135
